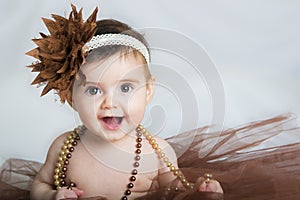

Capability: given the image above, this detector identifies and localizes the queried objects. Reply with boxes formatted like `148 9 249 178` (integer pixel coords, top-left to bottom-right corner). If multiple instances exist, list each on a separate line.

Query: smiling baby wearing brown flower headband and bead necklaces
28 6 223 200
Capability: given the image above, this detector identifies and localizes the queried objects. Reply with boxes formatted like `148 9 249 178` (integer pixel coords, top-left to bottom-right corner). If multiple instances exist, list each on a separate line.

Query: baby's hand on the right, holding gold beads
197 174 223 193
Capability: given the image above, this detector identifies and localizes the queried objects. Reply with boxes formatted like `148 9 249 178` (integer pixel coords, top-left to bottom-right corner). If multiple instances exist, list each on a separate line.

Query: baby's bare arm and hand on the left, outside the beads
30 134 82 200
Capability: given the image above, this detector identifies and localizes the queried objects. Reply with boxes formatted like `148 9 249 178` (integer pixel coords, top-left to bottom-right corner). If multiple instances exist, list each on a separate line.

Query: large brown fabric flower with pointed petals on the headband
26 5 98 105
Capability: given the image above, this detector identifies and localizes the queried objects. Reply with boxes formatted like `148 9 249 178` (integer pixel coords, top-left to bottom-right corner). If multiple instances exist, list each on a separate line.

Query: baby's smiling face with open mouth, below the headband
73 54 153 141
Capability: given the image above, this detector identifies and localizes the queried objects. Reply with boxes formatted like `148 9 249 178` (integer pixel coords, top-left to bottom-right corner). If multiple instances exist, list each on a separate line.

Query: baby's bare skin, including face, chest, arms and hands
31 52 223 200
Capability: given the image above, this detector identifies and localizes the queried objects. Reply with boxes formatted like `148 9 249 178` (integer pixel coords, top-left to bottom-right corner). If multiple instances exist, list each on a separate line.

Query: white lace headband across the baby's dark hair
85 33 150 64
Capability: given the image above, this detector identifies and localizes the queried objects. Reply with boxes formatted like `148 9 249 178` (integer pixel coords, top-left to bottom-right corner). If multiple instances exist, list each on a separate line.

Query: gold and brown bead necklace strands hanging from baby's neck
54 125 193 200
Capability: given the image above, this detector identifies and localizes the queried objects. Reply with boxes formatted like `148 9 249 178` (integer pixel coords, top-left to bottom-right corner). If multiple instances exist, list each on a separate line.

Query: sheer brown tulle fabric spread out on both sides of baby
0 114 300 200
